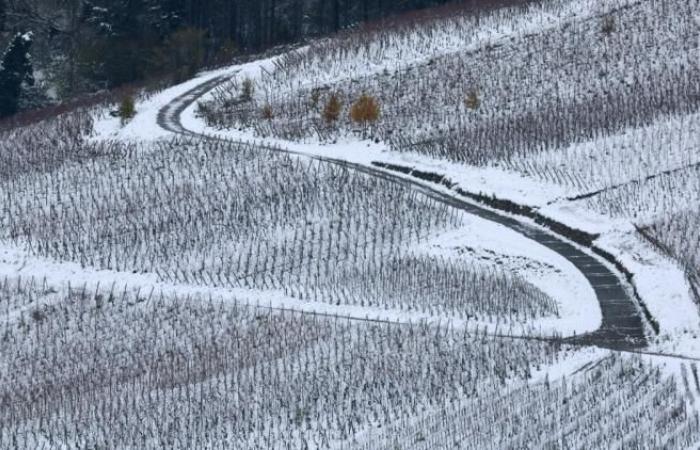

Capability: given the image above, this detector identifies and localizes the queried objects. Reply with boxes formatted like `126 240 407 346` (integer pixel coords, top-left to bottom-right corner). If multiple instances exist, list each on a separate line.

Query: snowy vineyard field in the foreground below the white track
0 279 700 449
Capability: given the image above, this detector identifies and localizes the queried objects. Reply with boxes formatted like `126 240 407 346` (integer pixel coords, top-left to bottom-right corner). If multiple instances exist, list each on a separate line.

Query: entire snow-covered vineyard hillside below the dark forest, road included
0 0 700 449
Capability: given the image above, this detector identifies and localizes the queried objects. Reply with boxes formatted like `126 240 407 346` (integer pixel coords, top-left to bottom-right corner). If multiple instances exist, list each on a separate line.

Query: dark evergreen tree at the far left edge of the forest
0 33 34 117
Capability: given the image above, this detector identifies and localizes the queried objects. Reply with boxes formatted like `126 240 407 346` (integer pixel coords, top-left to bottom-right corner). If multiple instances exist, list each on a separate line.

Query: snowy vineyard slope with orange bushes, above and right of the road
197 0 700 342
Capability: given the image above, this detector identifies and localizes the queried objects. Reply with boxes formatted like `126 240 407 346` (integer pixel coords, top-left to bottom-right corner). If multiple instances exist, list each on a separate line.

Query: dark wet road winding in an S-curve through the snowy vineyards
158 75 647 350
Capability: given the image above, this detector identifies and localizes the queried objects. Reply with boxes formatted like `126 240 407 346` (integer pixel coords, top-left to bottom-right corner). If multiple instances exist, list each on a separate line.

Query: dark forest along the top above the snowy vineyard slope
0 0 482 109
